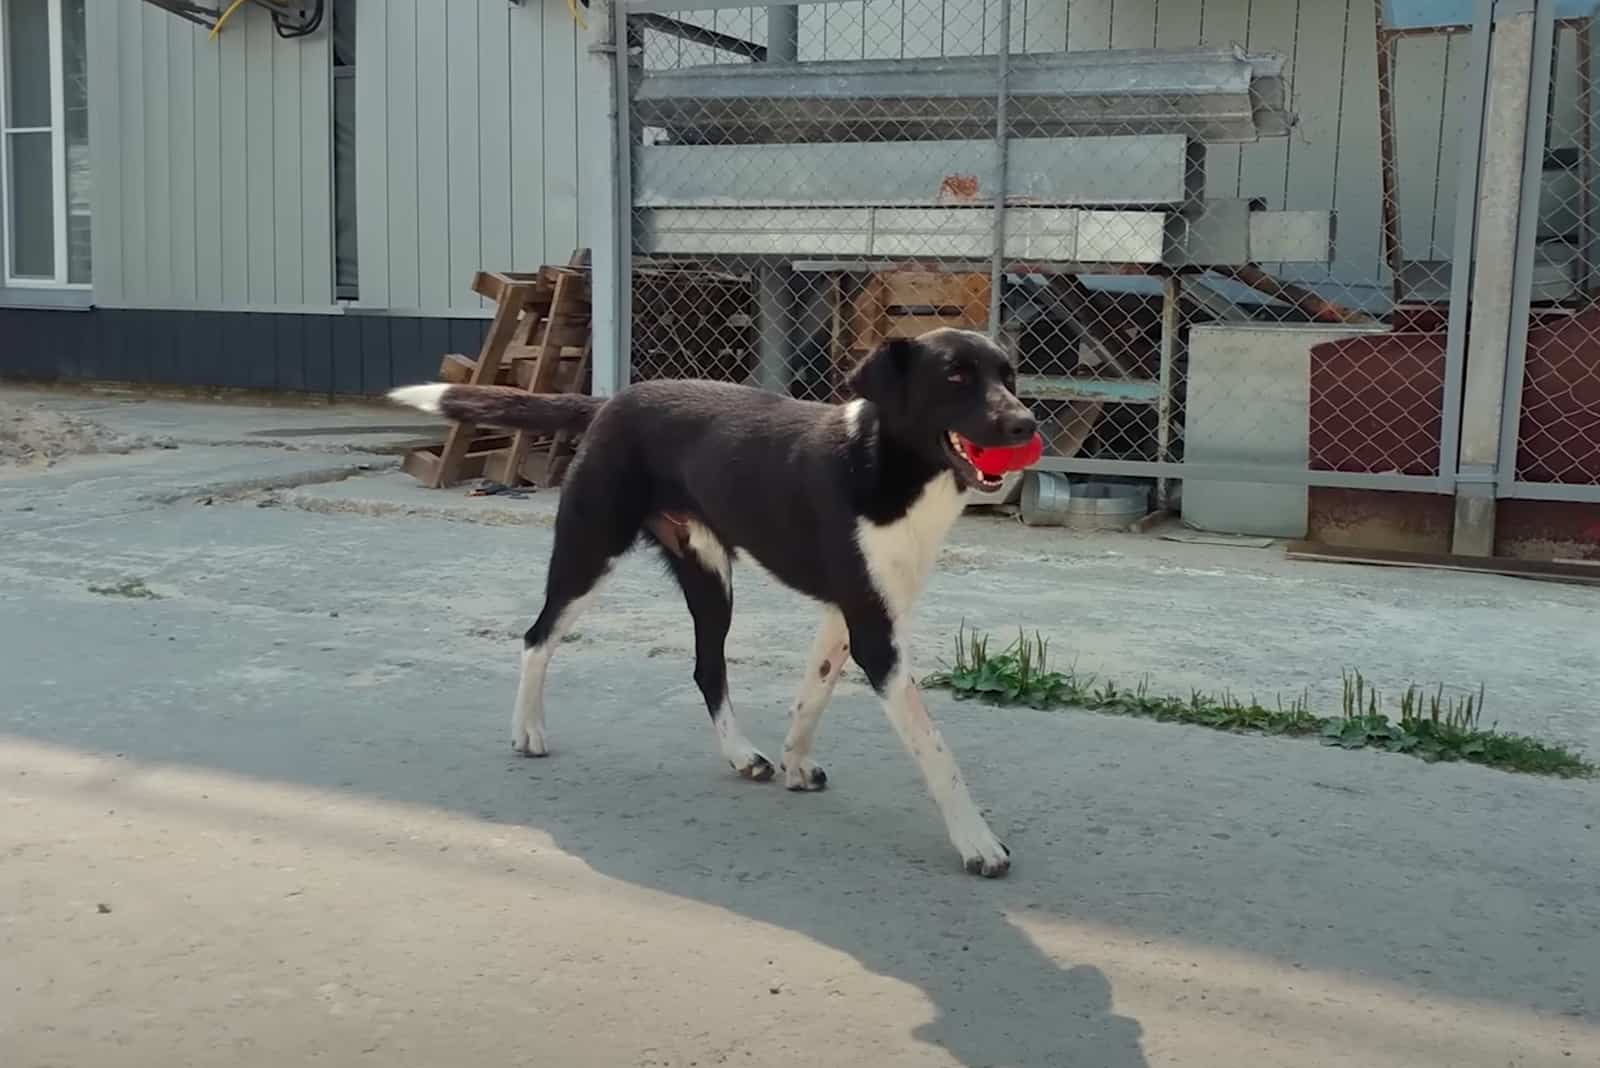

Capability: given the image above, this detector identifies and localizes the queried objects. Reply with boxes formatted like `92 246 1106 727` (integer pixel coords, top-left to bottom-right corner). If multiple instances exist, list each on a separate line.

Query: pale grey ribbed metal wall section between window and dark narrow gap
86 3 333 309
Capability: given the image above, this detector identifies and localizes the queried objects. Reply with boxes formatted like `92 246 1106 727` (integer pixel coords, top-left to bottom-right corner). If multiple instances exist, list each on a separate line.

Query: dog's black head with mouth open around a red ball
850 329 1035 491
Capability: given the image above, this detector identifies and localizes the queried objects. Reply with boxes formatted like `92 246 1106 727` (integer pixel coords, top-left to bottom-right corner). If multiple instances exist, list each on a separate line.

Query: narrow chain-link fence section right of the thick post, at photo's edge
1502 12 1600 500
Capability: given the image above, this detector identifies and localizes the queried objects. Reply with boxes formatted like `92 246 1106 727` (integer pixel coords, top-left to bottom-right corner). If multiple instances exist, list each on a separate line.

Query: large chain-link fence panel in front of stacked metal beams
627 0 1497 516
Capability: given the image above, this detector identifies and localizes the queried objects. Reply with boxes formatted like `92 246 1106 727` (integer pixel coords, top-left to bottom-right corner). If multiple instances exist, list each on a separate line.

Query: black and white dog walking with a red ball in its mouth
390 329 1034 878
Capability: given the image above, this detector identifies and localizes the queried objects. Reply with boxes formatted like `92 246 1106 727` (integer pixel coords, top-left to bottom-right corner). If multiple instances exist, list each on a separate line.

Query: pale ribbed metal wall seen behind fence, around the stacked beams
645 0 1536 300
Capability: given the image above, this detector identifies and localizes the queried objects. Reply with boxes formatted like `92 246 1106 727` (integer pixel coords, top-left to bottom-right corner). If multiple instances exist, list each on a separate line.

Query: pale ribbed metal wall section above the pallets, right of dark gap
355 0 608 313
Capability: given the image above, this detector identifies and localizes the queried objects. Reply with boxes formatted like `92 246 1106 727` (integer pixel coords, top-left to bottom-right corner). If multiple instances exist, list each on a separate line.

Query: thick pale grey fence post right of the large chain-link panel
1451 0 1538 556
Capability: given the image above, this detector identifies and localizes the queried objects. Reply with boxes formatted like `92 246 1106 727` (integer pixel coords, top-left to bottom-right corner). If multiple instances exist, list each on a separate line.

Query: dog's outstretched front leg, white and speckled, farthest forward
850 624 1011 879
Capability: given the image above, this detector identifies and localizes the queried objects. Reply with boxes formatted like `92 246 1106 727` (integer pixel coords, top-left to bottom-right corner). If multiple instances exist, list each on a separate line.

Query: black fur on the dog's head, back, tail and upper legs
397 329 1034 876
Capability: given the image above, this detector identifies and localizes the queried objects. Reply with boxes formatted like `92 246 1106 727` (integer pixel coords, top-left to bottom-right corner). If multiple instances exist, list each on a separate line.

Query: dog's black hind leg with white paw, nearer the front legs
666 523 774 782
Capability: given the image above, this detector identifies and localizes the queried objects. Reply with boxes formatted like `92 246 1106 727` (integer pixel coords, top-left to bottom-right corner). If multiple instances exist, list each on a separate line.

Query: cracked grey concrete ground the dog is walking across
0 385 1600 1068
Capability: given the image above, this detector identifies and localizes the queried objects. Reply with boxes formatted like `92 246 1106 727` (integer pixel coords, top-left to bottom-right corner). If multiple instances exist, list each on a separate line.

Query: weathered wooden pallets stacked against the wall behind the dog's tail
402 253 594 488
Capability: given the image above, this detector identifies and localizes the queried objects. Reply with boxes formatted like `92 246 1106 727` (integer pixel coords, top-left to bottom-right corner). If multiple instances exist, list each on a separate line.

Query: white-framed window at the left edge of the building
0 0 91 286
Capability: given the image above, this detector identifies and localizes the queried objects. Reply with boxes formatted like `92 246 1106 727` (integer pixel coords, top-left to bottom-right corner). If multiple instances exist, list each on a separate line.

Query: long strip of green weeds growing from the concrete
925 624 1597 779
